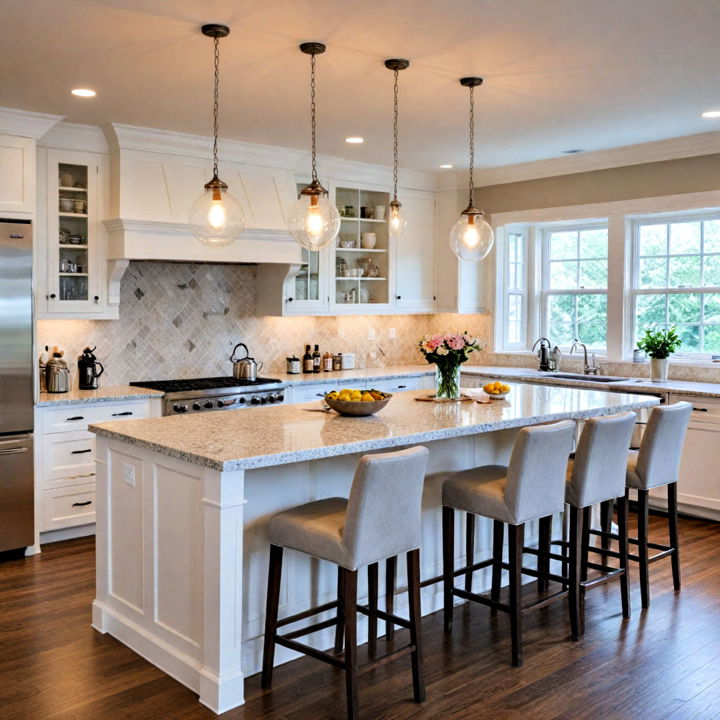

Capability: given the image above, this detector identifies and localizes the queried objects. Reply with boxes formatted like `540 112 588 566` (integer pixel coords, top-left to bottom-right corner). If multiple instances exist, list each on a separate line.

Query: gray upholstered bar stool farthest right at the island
593 402 692 608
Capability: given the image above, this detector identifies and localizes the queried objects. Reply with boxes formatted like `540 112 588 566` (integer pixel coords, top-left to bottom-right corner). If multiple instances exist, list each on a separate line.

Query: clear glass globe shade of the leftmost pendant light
189 177 245 247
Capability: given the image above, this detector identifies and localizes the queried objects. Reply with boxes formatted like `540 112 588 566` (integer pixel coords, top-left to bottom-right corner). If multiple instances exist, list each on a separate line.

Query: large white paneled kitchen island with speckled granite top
90 384 657 713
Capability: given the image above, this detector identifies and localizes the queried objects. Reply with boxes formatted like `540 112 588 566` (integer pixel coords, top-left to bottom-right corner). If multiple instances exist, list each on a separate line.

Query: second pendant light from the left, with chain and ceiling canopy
287 42 340 250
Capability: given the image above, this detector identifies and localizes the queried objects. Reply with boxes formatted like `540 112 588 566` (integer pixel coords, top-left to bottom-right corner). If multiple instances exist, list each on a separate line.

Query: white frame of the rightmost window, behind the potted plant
627 208 720 362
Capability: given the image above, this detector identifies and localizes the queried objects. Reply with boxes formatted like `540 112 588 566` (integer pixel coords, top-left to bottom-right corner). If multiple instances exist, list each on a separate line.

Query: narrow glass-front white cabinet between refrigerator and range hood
46 150 102 315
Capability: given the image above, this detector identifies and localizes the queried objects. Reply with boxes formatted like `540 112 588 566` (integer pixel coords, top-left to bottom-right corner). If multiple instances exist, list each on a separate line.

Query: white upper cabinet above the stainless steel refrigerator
0 135 35 214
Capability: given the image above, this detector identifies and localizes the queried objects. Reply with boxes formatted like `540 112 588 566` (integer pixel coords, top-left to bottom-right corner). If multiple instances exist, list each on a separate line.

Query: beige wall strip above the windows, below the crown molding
476 154 720 214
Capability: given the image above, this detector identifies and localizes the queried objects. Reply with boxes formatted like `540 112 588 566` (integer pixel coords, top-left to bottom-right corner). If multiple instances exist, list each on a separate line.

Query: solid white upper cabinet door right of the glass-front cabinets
395 190 435 313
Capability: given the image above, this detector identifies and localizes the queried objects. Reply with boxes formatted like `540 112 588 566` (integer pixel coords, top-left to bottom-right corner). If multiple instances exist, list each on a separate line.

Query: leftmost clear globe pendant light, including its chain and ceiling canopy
189 24 245 247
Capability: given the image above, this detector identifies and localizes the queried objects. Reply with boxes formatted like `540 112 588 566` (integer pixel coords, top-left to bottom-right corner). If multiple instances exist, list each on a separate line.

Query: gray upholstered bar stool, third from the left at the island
564 412 637 640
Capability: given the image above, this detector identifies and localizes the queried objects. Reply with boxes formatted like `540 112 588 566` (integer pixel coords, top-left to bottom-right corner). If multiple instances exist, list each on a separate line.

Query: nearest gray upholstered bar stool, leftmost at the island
262 447 428 720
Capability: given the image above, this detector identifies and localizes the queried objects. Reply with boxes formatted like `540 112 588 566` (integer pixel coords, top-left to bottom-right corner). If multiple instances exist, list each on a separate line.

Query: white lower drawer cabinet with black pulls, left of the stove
35 399 160 532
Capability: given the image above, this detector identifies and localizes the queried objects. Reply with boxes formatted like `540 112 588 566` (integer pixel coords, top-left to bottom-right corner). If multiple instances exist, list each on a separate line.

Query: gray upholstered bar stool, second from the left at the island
442 420 575 666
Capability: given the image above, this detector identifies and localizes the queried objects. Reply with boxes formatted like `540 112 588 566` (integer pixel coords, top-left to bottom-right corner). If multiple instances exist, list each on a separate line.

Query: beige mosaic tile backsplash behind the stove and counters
38 262 490 385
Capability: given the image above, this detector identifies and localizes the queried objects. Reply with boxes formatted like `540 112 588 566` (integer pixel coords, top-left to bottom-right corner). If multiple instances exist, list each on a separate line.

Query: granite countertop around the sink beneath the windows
462 365 720 397
